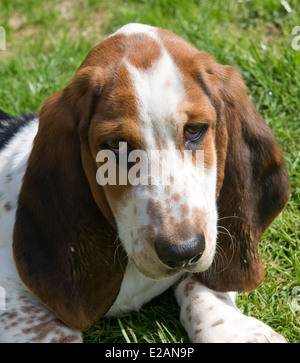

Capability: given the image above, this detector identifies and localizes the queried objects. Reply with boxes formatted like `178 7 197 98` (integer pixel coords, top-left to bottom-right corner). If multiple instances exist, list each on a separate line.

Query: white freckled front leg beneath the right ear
175 274 286 343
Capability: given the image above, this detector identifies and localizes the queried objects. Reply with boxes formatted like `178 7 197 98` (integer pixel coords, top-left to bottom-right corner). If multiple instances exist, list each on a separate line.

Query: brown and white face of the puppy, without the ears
85 27 217 279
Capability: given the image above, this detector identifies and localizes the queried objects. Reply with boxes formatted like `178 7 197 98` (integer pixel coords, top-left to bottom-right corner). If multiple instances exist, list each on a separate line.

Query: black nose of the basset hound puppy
154 233 205 268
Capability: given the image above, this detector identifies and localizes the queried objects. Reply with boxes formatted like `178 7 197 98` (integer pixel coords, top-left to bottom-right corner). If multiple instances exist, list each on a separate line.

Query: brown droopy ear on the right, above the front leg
198 65 289 291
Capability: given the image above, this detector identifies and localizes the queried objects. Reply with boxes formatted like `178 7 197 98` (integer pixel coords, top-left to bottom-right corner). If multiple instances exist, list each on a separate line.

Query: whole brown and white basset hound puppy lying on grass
0 24 289 342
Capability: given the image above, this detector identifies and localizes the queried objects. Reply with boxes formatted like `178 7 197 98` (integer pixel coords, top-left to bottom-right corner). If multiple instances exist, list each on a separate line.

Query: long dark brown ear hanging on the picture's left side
13 67 126 330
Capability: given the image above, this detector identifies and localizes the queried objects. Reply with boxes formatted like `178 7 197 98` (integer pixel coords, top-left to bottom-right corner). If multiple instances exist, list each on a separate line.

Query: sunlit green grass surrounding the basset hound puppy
0 0 300 342
